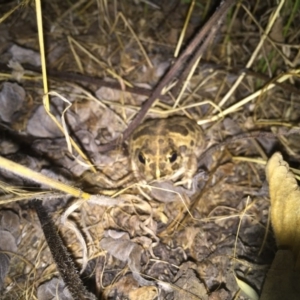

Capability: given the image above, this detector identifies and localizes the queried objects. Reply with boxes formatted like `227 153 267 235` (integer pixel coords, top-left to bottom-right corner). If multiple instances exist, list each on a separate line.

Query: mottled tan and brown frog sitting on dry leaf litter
129 116 205 188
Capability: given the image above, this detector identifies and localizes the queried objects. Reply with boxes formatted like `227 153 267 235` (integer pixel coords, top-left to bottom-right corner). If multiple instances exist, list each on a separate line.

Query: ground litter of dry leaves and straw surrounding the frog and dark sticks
0 0 300 300
